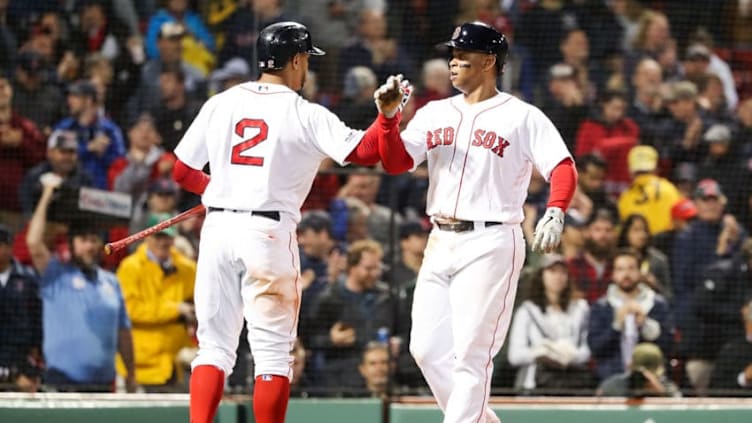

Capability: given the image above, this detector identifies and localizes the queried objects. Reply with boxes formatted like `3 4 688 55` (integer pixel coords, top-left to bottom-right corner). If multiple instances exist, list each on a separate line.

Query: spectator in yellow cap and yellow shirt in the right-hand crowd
619 145 681 235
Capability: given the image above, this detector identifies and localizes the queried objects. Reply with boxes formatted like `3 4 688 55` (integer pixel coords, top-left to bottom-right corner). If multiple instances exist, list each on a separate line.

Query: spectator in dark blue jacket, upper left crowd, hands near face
55 80 125 189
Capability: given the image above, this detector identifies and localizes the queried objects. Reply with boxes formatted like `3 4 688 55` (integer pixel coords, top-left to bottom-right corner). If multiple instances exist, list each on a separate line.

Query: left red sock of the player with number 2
191 366 225 423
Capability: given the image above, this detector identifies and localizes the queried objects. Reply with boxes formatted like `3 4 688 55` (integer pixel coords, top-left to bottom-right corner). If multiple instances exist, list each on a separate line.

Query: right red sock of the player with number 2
253 375 290 423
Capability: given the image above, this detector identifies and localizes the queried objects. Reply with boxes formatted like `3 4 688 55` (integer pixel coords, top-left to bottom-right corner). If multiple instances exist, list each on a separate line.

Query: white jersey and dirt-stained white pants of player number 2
184 82 363 378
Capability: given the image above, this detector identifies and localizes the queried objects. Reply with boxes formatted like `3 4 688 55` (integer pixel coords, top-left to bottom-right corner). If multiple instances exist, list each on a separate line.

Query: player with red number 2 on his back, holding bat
174 22 408 423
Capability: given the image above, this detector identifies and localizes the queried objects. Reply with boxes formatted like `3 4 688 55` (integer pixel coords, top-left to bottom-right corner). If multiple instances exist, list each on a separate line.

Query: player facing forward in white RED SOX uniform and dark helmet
375 22 577 423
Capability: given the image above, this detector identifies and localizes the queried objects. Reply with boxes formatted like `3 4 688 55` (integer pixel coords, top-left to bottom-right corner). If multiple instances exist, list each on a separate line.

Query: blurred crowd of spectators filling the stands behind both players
0 0 752 397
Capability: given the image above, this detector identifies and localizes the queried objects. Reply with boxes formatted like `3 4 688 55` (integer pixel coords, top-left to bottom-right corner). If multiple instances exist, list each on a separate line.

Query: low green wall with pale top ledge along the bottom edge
0 396 752 423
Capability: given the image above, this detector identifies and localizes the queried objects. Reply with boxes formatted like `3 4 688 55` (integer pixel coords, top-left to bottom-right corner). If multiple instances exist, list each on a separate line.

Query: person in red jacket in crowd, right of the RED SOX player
575 90 640 196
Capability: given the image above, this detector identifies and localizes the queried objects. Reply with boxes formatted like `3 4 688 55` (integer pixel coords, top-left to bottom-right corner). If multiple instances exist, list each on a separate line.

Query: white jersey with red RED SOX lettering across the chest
401 93 571 223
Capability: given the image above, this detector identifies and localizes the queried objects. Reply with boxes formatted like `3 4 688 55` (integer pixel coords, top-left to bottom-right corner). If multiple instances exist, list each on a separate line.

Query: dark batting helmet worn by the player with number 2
256 22 325 72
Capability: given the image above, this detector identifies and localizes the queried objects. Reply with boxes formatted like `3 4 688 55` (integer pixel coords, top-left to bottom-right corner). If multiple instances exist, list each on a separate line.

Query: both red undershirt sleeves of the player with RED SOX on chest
378 114 577 210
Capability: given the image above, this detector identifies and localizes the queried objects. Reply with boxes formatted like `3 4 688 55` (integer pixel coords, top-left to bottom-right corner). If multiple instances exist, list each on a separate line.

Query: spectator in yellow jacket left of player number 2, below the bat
117 214 196 391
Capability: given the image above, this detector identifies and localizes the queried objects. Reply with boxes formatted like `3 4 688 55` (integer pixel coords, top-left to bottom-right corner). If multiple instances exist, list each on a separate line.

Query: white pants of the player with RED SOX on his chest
410 224 525 423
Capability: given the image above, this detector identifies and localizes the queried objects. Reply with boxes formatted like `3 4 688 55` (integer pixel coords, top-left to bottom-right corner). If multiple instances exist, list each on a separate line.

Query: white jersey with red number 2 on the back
175 82 363 222
